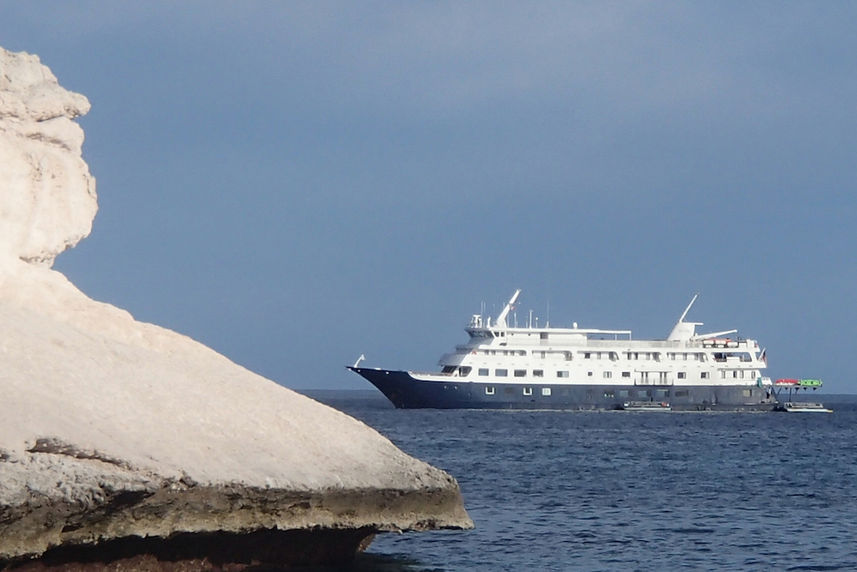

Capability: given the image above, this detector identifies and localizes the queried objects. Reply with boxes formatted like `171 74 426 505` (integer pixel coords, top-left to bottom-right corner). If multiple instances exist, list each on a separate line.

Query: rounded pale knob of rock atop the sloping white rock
0 48 97 266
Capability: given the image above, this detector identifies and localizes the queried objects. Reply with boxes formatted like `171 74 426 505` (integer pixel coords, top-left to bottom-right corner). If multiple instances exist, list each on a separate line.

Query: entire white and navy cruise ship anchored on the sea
349 290 778 411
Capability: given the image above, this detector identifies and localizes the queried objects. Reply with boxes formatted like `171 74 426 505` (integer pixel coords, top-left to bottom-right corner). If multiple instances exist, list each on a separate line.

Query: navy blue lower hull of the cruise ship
348 367 778 411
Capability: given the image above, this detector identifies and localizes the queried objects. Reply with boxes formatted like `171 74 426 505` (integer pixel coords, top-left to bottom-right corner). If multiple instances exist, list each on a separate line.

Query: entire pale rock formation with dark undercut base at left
0 48 472 570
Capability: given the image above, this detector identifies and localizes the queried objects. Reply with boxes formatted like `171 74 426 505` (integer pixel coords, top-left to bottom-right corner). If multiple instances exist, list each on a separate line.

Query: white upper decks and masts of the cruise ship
428 290 771 388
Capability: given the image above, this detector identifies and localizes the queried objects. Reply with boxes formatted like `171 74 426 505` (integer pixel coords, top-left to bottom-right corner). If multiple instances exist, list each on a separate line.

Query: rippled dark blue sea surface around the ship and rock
306 391 857 571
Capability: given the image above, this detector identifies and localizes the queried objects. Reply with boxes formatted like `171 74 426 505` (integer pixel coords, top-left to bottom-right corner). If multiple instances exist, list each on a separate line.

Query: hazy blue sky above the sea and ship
0 1 857 393
